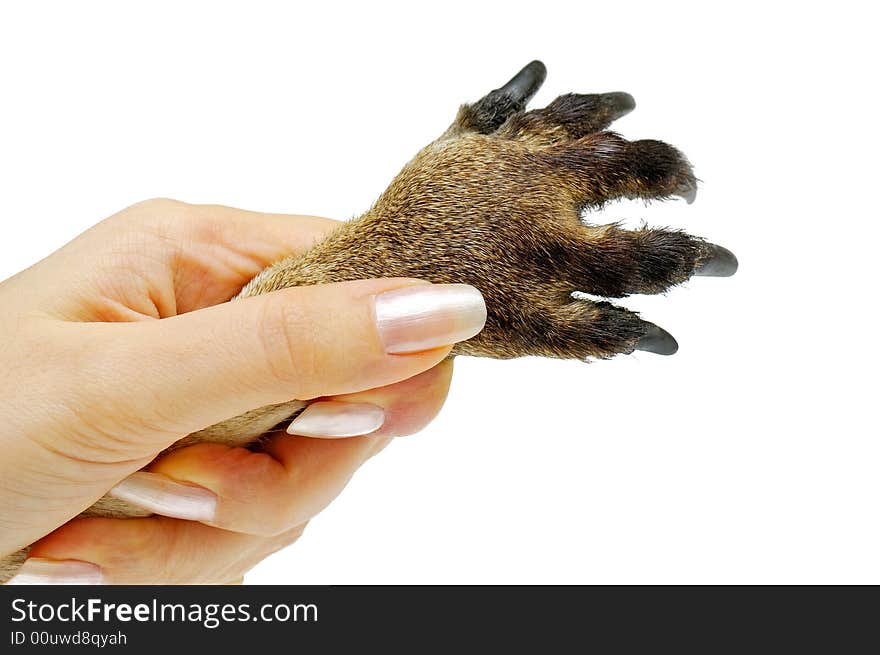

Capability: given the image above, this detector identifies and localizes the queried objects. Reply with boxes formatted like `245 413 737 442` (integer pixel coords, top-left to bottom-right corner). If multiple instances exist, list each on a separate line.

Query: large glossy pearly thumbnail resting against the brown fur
375 284 486 355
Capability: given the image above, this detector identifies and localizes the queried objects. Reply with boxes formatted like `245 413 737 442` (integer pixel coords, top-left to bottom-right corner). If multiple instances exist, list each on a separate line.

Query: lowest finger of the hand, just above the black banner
7 517 305 584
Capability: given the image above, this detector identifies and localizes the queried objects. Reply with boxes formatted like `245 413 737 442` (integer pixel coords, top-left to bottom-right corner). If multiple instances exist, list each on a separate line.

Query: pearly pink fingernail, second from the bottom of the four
110 471 217 521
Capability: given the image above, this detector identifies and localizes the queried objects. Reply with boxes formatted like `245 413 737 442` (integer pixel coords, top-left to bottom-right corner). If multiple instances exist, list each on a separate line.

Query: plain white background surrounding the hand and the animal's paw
0 1 880 584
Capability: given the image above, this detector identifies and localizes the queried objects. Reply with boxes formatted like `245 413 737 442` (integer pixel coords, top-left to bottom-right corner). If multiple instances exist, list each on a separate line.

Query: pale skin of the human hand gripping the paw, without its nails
0 200 482 584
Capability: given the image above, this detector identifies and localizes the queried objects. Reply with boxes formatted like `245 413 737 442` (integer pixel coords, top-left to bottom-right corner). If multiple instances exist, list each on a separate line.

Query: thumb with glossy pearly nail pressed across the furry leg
81 279 486 446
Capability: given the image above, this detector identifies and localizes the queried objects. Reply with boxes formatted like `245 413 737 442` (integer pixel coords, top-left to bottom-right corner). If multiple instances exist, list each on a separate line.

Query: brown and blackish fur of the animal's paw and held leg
0 62 720 580
